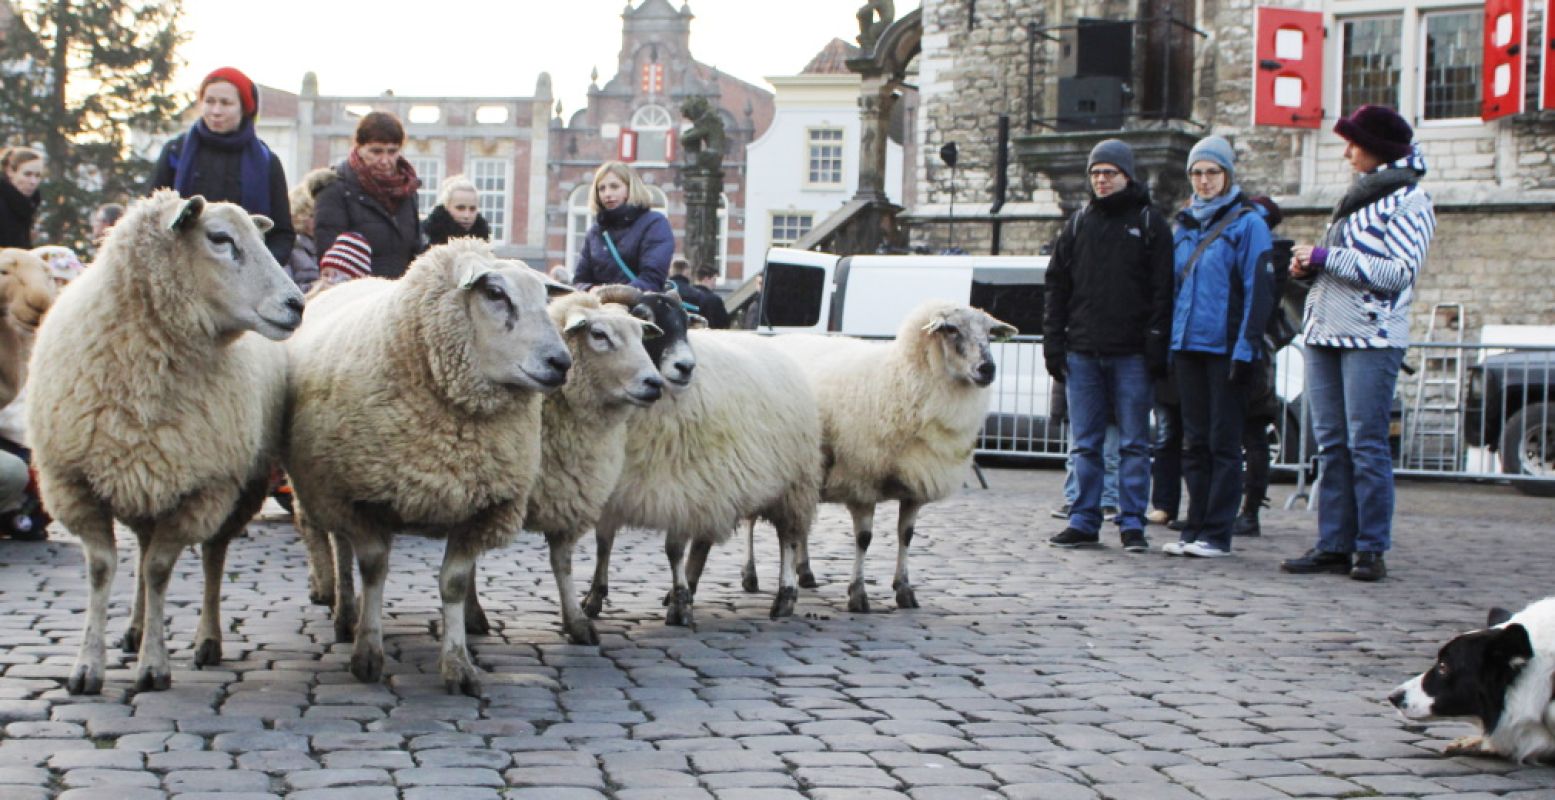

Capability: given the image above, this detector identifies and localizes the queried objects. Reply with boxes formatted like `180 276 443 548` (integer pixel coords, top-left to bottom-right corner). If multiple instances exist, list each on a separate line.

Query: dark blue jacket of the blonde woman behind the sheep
572 205 675 291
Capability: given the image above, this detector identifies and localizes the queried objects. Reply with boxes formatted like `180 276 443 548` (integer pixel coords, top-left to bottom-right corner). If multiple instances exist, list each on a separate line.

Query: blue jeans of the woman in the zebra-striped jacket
1306 346 1404 553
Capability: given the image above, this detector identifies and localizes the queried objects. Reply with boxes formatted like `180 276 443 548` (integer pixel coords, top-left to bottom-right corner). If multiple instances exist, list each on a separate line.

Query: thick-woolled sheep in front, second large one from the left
286 240 572 696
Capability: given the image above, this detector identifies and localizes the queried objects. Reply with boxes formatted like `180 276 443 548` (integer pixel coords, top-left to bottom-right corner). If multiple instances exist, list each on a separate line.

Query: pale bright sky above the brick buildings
177 0 919 117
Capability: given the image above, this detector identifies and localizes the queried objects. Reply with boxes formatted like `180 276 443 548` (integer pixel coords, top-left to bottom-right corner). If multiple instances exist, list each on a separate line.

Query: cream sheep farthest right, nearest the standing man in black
743 300 1017 612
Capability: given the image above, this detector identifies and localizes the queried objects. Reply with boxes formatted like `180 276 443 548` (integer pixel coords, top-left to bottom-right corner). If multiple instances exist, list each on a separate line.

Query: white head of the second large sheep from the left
457 252 572 392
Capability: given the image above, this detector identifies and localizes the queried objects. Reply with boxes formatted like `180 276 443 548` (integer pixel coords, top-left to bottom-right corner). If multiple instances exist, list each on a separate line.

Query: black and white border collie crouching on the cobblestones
1387 596 1555 763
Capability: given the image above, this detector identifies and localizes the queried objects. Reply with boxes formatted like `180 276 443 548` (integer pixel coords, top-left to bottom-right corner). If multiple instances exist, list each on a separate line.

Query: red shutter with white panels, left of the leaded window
1253 6 1323 128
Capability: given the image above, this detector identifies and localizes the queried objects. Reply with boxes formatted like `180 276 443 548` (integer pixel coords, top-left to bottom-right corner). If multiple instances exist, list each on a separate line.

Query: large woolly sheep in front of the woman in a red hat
28 190 303 694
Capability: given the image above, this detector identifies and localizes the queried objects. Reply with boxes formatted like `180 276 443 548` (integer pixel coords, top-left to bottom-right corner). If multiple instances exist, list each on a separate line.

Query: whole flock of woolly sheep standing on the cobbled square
28 191 1014 694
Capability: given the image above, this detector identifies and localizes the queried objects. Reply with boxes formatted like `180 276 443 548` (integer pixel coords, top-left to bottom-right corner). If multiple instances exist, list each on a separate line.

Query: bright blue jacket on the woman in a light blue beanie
1171 198 1274 361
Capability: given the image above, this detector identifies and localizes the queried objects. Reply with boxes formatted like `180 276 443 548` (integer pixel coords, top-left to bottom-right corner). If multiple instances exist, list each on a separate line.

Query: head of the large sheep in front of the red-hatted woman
159 191 303 341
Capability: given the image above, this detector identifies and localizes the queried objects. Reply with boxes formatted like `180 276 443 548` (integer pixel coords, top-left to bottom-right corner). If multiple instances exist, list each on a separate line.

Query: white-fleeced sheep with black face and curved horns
583 283 821 626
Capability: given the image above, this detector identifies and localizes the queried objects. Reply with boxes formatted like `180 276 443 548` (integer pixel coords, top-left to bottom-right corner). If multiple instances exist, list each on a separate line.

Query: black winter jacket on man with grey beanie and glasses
1042 184 1172 359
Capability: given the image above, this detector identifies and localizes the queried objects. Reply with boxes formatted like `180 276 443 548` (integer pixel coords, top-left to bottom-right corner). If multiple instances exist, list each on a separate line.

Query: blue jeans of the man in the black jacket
1065 353 1152 534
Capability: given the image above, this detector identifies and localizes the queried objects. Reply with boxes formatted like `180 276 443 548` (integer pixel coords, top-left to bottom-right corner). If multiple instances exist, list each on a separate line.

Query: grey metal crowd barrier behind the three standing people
977 336 1555 495
